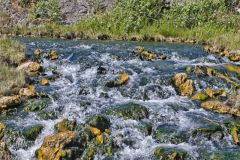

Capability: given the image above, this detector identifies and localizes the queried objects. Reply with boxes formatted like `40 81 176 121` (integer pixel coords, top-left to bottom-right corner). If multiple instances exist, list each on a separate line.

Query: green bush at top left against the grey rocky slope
30 0 60 22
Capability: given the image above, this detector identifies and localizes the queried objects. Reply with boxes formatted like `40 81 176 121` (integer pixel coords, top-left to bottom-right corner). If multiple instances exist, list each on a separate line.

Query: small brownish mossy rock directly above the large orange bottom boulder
55 119 77 132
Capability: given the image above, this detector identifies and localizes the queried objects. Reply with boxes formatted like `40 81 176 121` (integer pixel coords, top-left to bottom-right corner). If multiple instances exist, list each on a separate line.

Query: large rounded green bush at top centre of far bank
112 0 165 33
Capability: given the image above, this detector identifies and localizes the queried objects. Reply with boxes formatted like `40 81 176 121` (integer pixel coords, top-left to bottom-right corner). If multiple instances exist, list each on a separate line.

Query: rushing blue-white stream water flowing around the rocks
2 39 240 160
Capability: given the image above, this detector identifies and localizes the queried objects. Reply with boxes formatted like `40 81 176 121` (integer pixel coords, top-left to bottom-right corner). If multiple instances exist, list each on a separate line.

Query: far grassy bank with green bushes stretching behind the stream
6 0 240 50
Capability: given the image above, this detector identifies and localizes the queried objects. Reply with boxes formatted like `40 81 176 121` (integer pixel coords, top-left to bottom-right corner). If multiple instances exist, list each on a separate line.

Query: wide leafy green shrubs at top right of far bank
164 0 240 28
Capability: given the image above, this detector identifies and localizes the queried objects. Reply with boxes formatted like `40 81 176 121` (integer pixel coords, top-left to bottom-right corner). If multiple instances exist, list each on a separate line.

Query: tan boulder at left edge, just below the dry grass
0 96 21 111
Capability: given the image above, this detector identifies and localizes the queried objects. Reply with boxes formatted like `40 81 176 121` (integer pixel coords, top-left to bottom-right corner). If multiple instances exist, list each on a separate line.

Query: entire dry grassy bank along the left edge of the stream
0 38 25 95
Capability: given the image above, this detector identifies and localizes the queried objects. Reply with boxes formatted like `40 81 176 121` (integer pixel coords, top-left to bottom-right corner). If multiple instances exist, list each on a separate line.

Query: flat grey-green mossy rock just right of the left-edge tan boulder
23 98 50 112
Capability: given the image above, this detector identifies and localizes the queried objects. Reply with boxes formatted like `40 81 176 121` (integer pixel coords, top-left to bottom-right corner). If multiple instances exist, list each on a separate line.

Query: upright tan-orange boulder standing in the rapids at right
173 73 194 96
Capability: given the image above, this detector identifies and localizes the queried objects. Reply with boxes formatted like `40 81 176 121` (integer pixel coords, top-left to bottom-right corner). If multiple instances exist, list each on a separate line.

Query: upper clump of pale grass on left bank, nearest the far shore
0 38 26 65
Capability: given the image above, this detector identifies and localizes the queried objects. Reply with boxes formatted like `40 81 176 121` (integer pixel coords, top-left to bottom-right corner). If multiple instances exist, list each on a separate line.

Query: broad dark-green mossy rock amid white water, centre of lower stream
107 103 149 120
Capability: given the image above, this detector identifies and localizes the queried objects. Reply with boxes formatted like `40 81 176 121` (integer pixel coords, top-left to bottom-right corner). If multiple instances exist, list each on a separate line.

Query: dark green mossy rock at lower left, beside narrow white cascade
23 124 44 141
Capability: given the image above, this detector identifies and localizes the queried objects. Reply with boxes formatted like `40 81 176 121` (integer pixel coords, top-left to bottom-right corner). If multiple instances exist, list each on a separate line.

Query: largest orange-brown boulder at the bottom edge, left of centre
37 131 83 160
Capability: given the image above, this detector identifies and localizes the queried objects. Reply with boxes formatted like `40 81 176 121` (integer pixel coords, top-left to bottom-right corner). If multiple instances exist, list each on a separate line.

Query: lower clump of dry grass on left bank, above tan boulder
0 63 25 95
